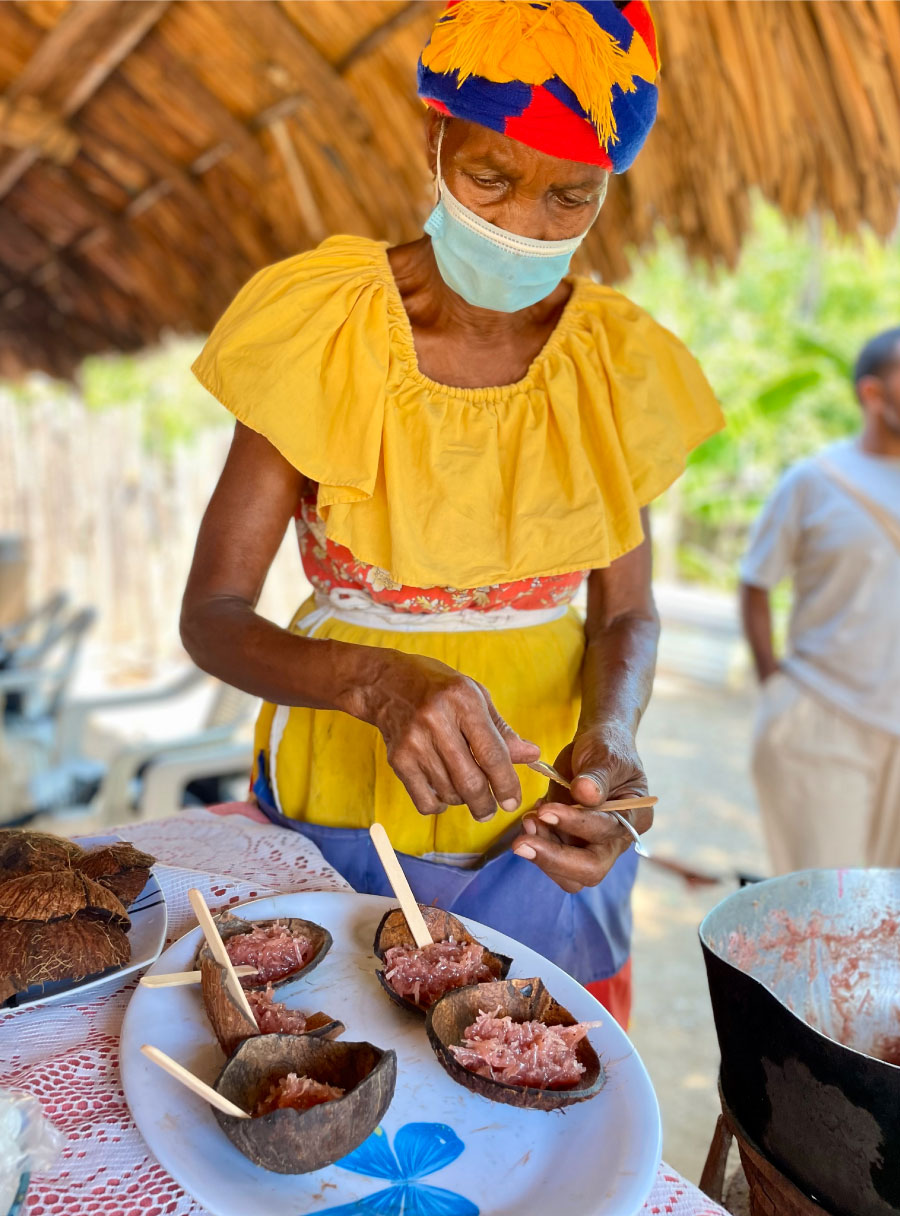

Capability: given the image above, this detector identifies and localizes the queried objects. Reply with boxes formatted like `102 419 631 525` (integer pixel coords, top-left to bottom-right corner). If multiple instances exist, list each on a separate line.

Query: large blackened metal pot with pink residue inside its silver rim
699 869 900 1216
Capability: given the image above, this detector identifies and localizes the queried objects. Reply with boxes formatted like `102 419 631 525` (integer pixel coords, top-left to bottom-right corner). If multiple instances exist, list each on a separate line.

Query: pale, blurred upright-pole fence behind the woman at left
0 390 308 677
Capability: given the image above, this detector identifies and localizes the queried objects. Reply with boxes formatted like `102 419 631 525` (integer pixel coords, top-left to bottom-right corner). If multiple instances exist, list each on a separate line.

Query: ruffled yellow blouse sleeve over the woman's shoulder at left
192 236 389 506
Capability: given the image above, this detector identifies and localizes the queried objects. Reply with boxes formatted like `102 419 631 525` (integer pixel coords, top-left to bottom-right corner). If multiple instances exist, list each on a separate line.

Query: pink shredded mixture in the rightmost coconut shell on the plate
450 1009 587 1090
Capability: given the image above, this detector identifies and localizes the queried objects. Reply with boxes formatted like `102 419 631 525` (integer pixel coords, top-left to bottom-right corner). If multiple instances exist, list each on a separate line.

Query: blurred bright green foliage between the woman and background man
623 204 900 585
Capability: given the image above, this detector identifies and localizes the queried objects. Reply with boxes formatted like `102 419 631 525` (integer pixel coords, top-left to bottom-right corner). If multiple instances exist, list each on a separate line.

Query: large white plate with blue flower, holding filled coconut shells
119 891 660 1216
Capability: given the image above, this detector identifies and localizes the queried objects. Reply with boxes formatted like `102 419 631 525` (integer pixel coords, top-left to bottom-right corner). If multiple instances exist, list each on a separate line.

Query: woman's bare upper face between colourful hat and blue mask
427 111 609 241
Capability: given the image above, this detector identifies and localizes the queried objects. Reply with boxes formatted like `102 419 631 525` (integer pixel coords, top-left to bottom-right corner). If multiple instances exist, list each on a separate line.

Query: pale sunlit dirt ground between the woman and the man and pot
630 675 767 1182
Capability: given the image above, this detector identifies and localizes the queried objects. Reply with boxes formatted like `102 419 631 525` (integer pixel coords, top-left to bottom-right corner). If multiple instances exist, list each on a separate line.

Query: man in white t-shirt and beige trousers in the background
741 328 900 873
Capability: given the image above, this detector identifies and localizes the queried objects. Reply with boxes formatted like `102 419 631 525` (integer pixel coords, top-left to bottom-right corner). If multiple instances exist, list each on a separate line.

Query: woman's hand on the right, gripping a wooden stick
512 727 653 893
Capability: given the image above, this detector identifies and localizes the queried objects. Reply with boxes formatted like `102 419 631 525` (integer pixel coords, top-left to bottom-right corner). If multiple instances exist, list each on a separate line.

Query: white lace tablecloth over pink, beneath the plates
0 810 725 1216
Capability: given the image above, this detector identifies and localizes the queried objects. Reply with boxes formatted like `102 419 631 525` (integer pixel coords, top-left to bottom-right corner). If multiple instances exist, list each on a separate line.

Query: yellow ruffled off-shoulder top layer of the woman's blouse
193 236 724 587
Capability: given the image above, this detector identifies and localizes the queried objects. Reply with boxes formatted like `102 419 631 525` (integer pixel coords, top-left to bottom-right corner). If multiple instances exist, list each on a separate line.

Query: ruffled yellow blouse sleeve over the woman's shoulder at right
584 285 725 507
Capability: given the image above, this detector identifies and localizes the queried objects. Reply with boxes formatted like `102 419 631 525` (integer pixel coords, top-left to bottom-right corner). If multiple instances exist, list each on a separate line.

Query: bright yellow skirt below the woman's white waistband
254 597 585 857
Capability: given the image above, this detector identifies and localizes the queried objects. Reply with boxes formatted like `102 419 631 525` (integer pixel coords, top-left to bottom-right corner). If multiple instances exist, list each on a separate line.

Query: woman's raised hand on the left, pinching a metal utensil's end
358 651 540 821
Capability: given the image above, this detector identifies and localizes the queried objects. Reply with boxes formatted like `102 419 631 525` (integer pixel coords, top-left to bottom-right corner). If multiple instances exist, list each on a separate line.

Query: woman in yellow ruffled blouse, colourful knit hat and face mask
182 0 721 1020
